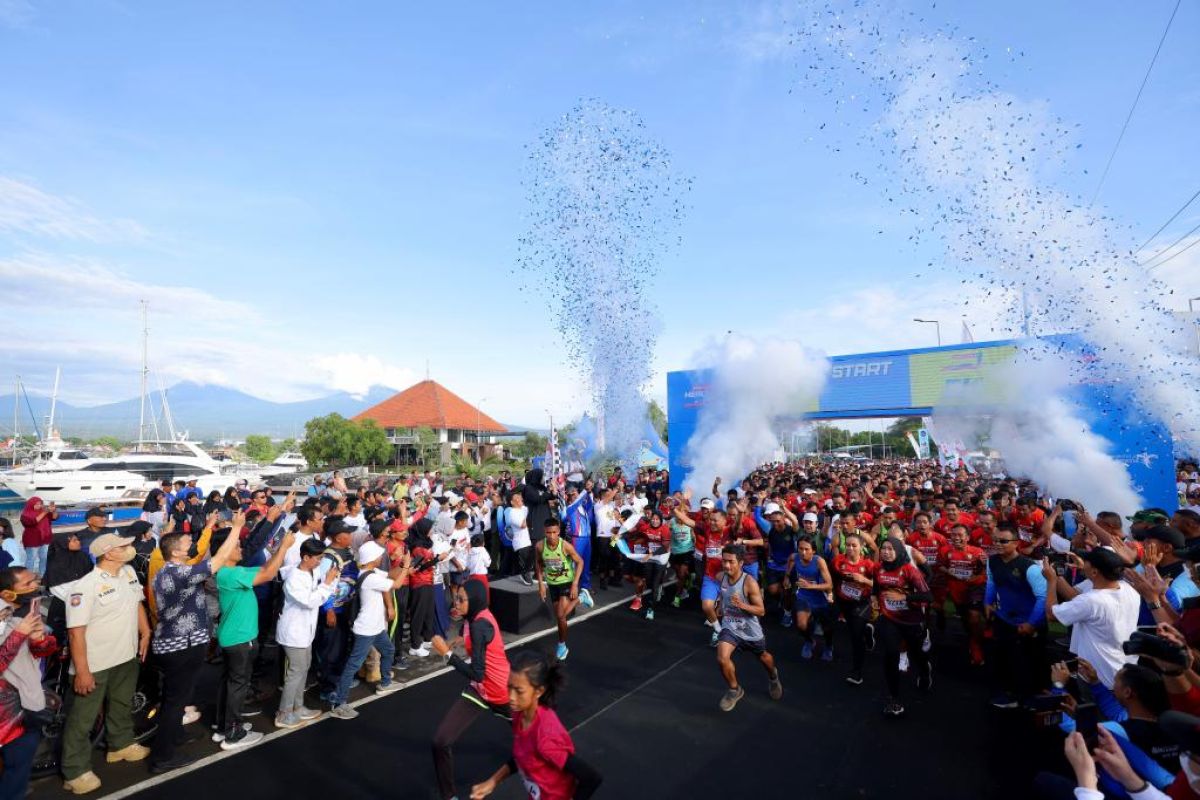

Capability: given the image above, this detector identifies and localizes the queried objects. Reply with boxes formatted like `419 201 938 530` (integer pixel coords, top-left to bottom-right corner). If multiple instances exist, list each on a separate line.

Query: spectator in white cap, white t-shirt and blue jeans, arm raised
330 541 410 720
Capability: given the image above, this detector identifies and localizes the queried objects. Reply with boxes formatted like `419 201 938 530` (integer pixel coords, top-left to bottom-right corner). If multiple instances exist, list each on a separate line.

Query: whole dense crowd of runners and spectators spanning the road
7 459 1200 799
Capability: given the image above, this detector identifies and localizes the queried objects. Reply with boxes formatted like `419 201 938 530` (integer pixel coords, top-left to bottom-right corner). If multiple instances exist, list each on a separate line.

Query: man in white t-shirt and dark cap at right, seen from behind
1042 547 1141 688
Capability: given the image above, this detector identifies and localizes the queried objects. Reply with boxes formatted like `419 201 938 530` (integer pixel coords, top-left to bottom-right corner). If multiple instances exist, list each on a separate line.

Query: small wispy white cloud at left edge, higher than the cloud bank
0 178 146 242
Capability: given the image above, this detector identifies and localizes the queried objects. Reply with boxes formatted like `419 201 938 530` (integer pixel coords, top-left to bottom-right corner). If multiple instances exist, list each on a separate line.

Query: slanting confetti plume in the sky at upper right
793 0 1200 453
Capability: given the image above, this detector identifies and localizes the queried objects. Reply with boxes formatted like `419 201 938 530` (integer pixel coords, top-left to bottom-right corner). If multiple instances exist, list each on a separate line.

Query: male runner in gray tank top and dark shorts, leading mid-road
716 545 784 711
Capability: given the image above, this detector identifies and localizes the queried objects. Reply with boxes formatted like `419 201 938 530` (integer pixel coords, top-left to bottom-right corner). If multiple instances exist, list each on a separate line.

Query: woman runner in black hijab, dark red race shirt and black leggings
874 536 934 717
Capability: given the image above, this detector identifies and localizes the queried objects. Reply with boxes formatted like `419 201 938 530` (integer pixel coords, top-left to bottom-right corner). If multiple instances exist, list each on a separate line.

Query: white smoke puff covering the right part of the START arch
934 347 1142 515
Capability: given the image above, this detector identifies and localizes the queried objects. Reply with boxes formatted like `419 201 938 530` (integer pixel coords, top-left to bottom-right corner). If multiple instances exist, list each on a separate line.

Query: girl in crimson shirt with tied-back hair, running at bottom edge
470 650 602 800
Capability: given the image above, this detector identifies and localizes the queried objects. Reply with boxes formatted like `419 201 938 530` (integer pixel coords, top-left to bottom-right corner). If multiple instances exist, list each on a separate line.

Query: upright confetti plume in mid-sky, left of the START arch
518 100 689 461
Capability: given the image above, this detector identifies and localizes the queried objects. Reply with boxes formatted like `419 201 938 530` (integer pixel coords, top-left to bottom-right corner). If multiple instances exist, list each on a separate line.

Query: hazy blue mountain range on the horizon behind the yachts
0 381 396 440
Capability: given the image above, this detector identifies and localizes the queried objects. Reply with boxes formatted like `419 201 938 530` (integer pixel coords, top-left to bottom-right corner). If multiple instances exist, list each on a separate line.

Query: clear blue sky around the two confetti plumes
0 0 1200 425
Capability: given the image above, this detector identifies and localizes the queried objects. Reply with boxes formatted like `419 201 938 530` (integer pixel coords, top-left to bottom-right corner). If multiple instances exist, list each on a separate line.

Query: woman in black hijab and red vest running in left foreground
433 581 511 800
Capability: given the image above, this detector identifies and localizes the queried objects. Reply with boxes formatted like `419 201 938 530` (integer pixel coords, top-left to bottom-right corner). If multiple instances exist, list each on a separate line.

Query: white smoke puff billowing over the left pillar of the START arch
684 335 829 494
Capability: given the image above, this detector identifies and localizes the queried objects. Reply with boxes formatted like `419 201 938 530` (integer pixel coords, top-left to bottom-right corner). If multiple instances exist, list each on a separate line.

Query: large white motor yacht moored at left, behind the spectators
0 437 262 506
